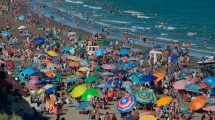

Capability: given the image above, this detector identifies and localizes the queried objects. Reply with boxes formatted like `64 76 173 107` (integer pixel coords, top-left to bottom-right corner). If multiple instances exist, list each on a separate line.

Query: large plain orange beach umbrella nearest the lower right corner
190 96 206 110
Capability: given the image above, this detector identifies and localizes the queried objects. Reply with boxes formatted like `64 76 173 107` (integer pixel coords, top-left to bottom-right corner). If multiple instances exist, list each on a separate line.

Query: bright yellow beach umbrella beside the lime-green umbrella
71 84 87 98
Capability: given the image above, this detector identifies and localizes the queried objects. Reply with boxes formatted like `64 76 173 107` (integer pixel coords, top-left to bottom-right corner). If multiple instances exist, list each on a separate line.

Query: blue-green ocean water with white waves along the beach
31 0 215 58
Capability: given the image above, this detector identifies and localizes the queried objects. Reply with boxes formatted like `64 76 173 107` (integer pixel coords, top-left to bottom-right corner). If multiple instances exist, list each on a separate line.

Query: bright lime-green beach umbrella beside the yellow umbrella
81 88 99 101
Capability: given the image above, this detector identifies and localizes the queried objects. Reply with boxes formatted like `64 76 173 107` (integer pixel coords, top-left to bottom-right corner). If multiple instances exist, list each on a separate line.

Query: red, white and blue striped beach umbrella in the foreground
117 95 136 113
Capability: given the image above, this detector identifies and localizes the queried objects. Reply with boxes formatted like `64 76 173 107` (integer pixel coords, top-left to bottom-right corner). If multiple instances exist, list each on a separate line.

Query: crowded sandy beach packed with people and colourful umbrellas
0 1 215 120
